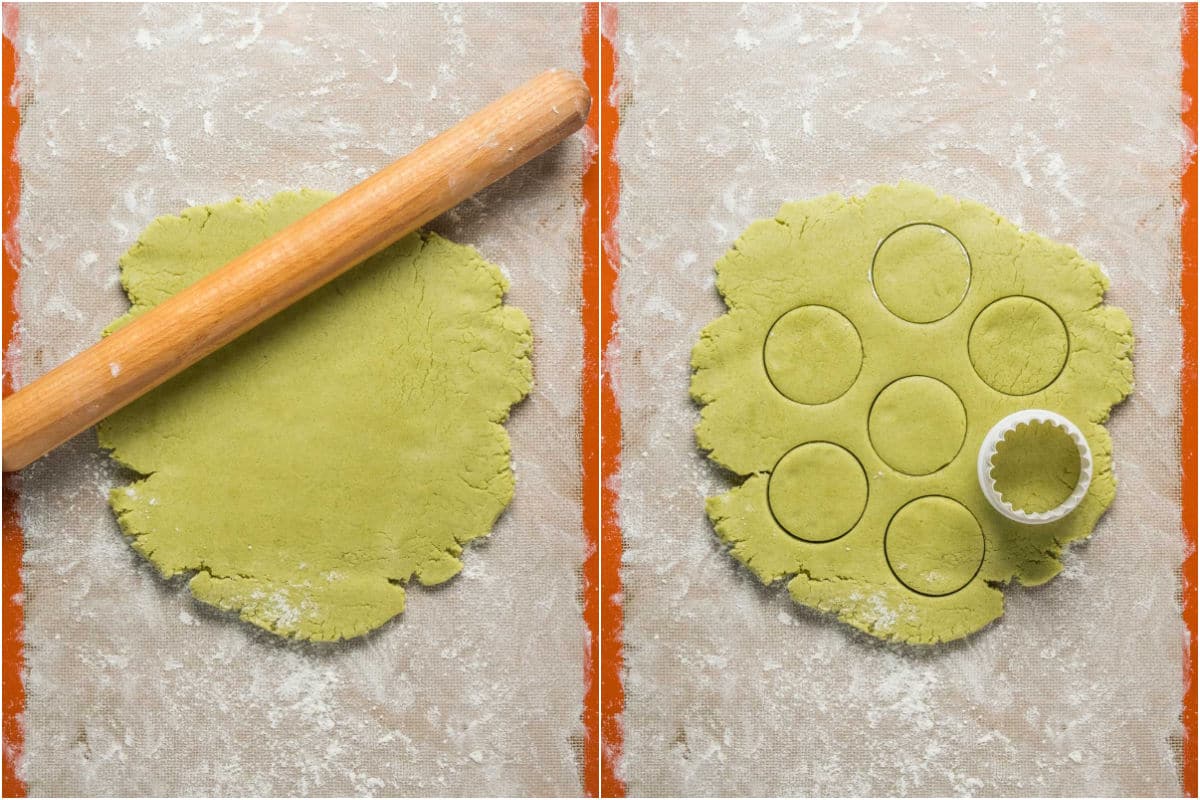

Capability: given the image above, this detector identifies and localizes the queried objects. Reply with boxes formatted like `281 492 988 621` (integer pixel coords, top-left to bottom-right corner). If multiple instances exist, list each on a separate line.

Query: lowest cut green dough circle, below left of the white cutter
883 495 985 597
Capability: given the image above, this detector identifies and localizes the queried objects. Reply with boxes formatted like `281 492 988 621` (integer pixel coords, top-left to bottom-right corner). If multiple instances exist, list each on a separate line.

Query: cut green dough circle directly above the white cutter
967 296 1070 395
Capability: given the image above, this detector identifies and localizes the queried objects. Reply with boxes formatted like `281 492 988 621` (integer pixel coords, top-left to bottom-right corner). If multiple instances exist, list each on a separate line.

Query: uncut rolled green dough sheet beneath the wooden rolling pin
98 191 532 640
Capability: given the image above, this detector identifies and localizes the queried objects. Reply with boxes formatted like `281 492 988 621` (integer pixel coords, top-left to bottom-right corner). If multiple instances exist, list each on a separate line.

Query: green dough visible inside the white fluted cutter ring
991 422 1080 513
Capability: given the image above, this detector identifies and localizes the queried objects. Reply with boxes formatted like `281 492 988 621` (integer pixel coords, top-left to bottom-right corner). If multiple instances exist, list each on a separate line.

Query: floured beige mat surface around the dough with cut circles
610 5 1187 796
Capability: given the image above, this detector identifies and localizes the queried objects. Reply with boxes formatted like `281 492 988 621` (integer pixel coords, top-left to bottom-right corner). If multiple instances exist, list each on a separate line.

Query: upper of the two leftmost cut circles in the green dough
762 306 863 405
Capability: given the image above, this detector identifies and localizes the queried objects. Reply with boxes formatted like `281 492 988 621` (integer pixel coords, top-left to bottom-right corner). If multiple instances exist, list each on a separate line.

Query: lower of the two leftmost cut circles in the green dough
767 441 866 542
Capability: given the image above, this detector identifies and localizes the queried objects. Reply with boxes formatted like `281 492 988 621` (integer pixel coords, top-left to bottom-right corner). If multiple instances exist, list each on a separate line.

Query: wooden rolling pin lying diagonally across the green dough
4 70 592 473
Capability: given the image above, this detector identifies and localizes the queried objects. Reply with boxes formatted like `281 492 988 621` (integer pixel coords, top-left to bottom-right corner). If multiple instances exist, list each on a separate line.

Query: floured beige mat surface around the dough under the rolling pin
10 5 587 796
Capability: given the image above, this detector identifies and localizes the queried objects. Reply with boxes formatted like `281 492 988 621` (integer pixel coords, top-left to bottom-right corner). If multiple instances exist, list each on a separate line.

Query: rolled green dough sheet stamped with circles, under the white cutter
691 184 1133 643
